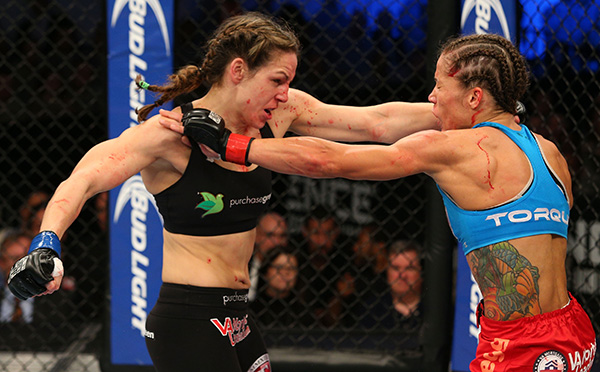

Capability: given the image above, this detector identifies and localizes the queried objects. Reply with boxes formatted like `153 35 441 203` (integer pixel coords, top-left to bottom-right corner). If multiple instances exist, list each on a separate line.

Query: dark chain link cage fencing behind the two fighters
0 0 600 372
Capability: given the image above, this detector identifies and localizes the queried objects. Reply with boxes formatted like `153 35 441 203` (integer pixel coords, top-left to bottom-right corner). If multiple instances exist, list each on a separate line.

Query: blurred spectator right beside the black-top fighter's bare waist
248 212 288 301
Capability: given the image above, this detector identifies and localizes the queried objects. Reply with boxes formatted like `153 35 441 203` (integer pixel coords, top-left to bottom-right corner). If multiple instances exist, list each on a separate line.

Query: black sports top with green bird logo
154 104 273 236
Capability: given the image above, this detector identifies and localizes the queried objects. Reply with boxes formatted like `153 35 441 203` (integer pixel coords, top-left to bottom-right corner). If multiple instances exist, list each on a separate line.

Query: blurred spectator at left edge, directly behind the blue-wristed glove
0 230 35 323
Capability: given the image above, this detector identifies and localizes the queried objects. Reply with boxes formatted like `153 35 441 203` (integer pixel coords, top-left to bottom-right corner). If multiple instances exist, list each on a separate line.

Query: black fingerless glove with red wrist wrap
181 109 254 166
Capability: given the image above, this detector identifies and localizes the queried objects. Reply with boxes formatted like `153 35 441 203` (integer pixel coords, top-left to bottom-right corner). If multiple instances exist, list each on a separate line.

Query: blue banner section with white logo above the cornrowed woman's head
460 0 516 40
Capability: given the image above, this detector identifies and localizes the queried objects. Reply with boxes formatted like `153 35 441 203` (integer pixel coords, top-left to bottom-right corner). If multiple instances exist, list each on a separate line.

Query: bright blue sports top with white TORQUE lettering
438 122 569 255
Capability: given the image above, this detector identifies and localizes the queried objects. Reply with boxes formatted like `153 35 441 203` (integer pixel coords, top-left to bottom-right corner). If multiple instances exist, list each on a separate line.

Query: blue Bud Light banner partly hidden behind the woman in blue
452 0 517 372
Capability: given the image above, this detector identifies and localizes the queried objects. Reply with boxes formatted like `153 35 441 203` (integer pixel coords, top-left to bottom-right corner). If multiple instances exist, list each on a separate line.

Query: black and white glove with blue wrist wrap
8 231 63 300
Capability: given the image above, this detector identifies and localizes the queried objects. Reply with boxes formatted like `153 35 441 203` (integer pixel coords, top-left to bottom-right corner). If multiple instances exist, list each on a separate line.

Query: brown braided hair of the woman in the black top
135 12 300 123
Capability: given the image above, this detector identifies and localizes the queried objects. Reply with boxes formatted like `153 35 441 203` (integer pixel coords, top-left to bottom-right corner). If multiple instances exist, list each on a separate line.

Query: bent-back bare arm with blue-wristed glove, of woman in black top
8 120 173 300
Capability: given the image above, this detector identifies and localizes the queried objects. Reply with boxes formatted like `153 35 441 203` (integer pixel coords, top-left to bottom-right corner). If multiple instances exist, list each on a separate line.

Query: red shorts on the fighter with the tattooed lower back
469 294 596 372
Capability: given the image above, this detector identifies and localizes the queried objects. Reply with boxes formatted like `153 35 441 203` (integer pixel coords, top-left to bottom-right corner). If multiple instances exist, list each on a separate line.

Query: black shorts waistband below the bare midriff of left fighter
158 283 248 310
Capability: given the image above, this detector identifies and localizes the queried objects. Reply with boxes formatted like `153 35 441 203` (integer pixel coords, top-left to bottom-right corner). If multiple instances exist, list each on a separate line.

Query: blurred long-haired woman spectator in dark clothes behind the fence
250 246 312 327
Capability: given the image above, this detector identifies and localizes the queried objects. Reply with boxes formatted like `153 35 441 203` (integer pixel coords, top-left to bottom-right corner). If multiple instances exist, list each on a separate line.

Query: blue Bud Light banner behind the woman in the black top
107 0 173 366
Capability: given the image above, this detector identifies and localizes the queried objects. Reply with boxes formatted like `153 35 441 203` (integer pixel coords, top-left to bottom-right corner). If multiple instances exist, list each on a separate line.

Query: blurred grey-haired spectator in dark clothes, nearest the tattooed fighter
358 240 423 349
